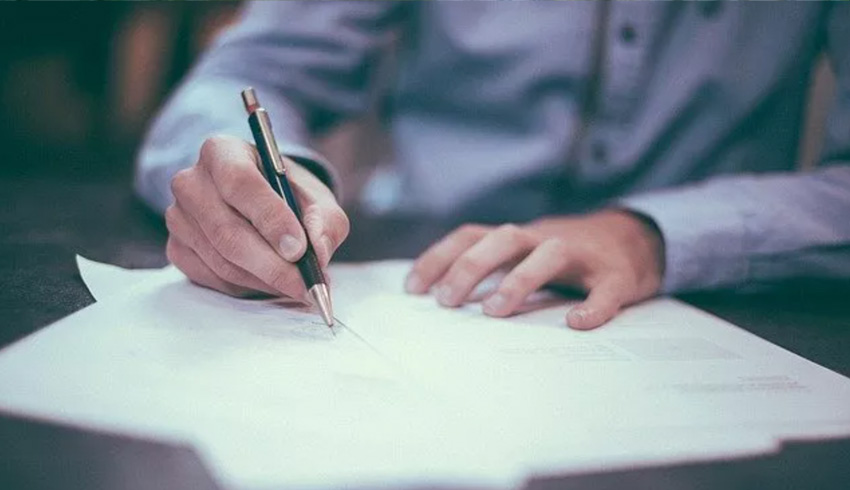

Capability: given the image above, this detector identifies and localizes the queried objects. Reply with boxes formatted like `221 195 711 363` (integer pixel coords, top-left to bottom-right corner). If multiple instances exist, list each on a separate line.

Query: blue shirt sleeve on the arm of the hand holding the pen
134 2 401 212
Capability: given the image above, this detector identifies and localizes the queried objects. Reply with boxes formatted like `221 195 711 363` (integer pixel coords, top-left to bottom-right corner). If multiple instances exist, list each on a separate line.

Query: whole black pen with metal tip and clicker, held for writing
242 87 334 332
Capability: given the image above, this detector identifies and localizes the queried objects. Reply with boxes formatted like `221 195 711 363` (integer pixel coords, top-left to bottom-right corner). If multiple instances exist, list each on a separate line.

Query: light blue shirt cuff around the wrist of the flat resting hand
617 188 749 294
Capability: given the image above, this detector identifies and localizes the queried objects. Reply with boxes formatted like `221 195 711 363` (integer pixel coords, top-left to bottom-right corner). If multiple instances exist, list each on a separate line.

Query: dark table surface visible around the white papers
0 178 850 489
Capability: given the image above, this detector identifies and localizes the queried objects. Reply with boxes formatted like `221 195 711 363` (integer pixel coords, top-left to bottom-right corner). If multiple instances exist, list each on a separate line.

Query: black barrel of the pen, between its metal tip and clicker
248 114 327 291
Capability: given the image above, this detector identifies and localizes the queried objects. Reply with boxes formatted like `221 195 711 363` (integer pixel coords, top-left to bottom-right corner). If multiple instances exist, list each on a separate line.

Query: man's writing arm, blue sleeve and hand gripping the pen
136 2 398 299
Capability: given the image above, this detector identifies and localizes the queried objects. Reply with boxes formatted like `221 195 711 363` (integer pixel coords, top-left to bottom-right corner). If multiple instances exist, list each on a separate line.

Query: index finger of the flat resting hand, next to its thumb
482 239 570 317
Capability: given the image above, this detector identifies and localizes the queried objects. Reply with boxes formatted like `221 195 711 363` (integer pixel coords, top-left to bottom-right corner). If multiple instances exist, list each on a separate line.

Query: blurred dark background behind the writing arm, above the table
0 1 380 196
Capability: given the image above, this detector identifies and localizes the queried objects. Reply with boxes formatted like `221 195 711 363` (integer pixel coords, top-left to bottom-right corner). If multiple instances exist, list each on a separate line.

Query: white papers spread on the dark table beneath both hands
0 259 850 488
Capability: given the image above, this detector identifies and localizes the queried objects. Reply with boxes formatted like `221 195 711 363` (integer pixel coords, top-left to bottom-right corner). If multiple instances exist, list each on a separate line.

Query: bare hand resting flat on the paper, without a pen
405 210 664 329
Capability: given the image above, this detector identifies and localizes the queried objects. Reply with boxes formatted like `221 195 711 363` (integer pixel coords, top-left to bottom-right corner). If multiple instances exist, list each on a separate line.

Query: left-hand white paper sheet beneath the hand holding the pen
8 261 517 488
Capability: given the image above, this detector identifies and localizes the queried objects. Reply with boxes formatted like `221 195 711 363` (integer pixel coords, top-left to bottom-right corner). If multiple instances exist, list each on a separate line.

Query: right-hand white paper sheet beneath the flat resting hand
335 263 850 482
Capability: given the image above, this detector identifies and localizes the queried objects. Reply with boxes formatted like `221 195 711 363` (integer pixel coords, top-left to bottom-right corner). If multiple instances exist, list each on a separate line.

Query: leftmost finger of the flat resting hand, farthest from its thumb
405 225 488 294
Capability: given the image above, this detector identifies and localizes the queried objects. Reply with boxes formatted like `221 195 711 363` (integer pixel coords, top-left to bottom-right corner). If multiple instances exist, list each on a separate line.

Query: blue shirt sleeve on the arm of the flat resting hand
620 5 850 293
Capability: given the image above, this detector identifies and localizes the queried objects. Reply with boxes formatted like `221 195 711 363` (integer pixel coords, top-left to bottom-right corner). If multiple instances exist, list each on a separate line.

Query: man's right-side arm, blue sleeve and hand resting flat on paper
407 4 850 329
